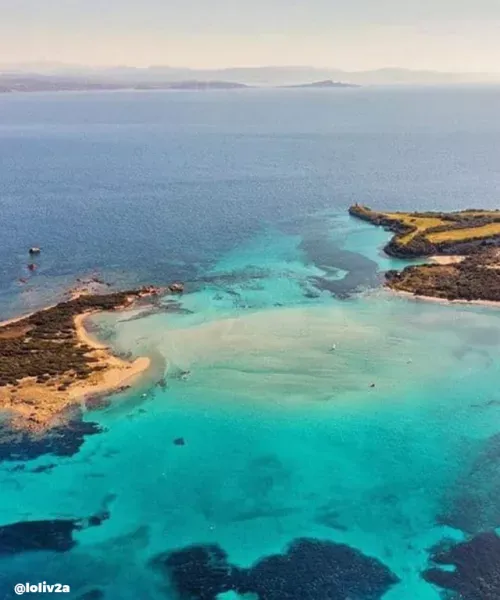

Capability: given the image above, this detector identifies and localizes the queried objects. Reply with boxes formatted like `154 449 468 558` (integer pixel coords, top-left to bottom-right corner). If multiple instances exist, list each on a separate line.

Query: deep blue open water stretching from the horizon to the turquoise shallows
0 88 500 316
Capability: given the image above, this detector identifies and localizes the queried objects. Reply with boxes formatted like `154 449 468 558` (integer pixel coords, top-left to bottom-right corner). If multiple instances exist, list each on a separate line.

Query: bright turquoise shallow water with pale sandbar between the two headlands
2 217 500 600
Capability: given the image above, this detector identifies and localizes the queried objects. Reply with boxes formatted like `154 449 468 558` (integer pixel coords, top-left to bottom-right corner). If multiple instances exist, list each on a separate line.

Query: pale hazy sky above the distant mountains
0 0 500 73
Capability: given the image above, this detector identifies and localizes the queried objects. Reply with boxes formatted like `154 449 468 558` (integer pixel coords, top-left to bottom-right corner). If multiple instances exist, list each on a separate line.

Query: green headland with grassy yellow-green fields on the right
349 204 500 302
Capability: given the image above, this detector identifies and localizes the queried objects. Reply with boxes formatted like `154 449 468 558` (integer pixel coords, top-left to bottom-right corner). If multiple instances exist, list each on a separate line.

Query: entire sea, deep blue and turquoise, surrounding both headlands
0 86 500 600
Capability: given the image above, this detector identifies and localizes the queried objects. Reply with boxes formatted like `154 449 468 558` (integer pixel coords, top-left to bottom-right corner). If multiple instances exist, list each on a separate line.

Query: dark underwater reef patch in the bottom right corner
423 532 500 600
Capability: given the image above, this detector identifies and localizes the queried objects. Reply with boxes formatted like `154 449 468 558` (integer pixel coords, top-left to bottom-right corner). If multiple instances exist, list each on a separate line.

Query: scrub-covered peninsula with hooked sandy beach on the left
0 286 164 434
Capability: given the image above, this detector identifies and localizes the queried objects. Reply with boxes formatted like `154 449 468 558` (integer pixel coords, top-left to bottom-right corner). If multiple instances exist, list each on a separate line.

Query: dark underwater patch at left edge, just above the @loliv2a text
0 511 109 556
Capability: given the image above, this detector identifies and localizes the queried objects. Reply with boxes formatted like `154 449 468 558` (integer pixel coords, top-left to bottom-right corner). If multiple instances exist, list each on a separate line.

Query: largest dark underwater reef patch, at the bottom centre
153 538 399 600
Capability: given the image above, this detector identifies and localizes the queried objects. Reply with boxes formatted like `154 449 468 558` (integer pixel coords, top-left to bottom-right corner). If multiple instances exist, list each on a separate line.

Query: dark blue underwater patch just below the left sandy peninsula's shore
0 410 103 461
